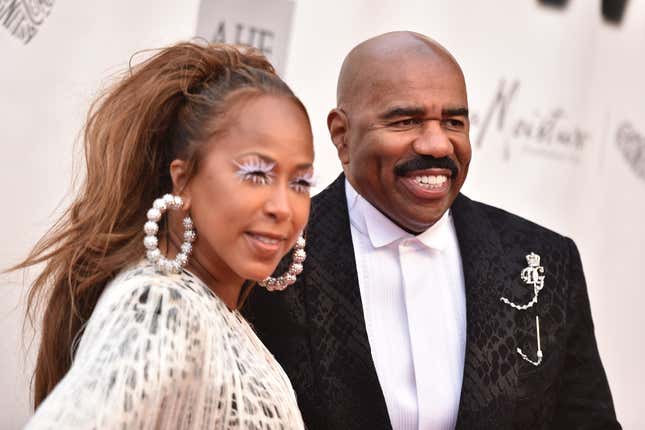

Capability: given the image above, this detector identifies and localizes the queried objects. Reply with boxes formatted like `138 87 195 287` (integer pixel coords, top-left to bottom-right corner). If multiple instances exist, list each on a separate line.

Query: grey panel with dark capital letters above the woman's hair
197 0 293 75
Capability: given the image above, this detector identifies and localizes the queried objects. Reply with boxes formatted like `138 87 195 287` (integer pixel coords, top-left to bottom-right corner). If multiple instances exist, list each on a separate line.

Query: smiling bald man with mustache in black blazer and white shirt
243 32 620 429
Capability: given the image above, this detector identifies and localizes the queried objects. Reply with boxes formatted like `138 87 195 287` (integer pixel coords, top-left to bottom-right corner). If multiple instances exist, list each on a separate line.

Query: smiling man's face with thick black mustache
341 55 471 233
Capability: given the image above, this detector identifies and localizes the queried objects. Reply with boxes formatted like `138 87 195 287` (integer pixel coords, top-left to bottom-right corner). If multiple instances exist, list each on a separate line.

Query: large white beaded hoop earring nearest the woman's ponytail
143 194 197 273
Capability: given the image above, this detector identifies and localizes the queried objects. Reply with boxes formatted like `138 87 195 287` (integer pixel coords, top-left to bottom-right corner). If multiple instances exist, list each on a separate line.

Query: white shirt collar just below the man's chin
345 179 452 251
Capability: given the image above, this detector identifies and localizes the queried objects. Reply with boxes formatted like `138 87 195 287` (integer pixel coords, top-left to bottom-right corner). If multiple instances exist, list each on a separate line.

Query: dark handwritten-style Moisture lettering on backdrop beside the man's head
471 79 590 163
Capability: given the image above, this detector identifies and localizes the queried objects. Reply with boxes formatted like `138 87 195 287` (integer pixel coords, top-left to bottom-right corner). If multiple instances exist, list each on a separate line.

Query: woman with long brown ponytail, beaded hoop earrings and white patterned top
19 43 313 429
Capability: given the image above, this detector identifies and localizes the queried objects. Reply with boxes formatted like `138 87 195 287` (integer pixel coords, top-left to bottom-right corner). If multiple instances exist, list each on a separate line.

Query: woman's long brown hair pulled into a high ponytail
11 43 306 407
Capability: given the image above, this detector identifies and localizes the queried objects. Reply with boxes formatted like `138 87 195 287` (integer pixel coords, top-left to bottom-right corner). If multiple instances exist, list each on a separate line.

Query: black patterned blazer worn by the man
245 175 620 430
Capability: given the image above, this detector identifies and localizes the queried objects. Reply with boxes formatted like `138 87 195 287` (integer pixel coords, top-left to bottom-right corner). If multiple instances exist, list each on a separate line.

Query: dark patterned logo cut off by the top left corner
0 0 54 44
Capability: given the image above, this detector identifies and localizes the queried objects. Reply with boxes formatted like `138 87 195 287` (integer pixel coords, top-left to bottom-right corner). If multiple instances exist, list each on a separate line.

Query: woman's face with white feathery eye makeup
181 95 314 280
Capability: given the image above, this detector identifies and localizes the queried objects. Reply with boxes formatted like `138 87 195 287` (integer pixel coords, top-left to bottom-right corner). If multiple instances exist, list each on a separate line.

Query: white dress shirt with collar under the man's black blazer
345 180 466 430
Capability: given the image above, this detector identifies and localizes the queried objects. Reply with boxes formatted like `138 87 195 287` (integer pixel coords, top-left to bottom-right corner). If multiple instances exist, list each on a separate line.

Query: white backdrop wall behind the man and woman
0 0 645 429
